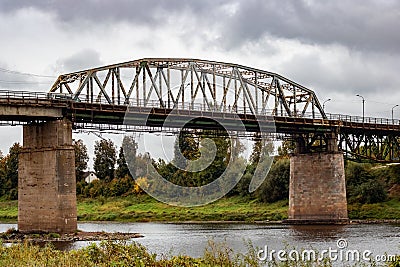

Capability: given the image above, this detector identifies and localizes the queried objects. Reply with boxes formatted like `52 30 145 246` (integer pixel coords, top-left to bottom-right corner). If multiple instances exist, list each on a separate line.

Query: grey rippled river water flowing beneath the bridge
0 222 400 264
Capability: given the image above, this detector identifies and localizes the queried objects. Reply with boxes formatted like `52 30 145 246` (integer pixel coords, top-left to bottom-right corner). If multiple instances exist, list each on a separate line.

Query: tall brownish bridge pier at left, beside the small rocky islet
18 119 77 233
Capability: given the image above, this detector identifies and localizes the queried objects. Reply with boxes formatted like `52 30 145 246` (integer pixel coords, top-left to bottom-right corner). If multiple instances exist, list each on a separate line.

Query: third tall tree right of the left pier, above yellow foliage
115 135 137 178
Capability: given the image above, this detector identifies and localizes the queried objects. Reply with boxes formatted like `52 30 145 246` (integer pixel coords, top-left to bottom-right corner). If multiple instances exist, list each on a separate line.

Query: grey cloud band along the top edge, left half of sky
0 0 219 25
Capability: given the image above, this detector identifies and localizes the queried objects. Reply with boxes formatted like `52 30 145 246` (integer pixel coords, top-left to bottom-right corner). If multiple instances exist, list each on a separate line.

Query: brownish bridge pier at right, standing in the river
286 136 348 224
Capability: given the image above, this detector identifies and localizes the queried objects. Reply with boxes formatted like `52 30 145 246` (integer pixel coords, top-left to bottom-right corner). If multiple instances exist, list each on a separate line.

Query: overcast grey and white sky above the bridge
0 0 400 161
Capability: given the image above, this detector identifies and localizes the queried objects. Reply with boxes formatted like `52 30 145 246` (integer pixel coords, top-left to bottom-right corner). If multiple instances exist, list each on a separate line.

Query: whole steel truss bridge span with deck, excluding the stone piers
0 58 400 162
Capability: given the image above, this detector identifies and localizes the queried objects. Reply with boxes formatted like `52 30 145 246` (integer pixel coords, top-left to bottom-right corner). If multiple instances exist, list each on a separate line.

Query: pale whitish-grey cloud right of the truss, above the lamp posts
284 51 400 95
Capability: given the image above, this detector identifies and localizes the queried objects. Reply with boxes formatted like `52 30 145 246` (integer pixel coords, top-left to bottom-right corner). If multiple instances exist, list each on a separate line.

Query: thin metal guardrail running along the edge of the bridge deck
0 90 400 125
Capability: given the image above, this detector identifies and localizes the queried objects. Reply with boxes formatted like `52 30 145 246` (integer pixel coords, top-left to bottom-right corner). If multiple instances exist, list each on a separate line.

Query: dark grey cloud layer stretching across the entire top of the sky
0 0 400 53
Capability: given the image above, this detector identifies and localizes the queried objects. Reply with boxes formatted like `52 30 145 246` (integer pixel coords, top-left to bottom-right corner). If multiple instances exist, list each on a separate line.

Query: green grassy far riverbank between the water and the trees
0 195 400 222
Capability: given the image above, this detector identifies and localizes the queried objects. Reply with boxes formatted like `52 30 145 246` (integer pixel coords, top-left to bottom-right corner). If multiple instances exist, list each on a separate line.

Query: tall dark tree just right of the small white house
93 139 117 182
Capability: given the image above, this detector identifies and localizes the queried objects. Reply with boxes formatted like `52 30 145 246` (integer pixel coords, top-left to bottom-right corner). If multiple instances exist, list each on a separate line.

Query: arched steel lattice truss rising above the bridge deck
50 58 326 118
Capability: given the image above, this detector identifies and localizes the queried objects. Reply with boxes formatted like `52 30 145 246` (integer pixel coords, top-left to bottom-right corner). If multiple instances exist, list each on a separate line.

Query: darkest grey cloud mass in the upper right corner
223 0 400 52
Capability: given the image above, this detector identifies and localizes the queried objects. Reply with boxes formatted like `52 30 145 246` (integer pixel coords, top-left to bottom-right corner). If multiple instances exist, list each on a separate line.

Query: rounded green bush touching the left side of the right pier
256 159 290 203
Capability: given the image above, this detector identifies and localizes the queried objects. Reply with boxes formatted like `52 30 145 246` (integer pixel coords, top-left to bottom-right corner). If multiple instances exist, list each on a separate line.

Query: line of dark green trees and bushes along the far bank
0 135 400 203
